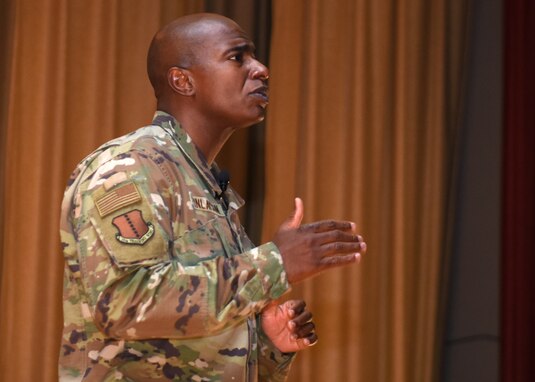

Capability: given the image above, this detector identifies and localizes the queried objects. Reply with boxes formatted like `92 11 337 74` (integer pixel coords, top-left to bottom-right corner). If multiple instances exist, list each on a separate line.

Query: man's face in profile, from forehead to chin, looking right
190 23 268 128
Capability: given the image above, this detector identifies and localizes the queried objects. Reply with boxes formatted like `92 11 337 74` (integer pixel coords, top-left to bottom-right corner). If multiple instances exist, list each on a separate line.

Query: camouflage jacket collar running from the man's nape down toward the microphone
152 110 244 209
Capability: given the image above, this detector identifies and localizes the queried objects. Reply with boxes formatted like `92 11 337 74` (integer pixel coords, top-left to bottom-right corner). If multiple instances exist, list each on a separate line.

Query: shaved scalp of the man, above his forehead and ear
147 13 245 99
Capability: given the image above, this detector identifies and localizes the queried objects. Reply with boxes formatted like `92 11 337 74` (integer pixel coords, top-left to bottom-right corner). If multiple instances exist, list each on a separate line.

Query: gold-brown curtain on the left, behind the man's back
0 0 204 381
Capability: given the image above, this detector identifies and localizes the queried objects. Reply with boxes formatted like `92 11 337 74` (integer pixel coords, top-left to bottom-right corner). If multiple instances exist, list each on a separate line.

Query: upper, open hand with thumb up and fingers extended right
273 198 366 284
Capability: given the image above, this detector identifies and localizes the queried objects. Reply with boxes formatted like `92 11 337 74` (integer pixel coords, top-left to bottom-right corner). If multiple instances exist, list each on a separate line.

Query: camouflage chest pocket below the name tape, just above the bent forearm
174 216 240 266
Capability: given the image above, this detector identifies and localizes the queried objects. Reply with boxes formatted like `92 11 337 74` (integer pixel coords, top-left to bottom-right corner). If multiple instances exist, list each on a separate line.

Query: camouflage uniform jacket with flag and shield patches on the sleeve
59 112 293 381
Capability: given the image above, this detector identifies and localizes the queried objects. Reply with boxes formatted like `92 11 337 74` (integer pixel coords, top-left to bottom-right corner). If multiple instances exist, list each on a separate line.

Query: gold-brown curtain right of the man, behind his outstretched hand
263 0 467 382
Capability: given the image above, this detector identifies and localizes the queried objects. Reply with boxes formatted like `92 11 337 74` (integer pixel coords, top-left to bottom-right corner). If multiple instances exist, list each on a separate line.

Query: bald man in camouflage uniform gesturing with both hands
59 14 365 381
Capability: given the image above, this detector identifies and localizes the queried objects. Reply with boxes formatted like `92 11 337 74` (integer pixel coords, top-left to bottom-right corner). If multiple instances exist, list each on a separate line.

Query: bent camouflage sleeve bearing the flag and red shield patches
73 148 289 339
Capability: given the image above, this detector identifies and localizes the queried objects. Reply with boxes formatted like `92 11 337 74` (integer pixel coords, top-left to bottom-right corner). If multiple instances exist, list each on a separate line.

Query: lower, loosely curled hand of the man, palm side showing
260 300 318 353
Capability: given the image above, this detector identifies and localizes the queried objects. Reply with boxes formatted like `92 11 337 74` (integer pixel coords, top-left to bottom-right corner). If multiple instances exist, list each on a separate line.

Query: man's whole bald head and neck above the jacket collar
147 13 269 145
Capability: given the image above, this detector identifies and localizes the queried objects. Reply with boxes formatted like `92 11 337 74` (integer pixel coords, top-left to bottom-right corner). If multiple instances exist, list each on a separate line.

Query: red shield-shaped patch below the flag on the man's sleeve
112 210 154 245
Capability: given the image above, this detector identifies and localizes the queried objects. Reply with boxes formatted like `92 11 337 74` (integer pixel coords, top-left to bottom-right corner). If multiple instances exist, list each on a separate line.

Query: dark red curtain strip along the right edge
502 0 535 382
